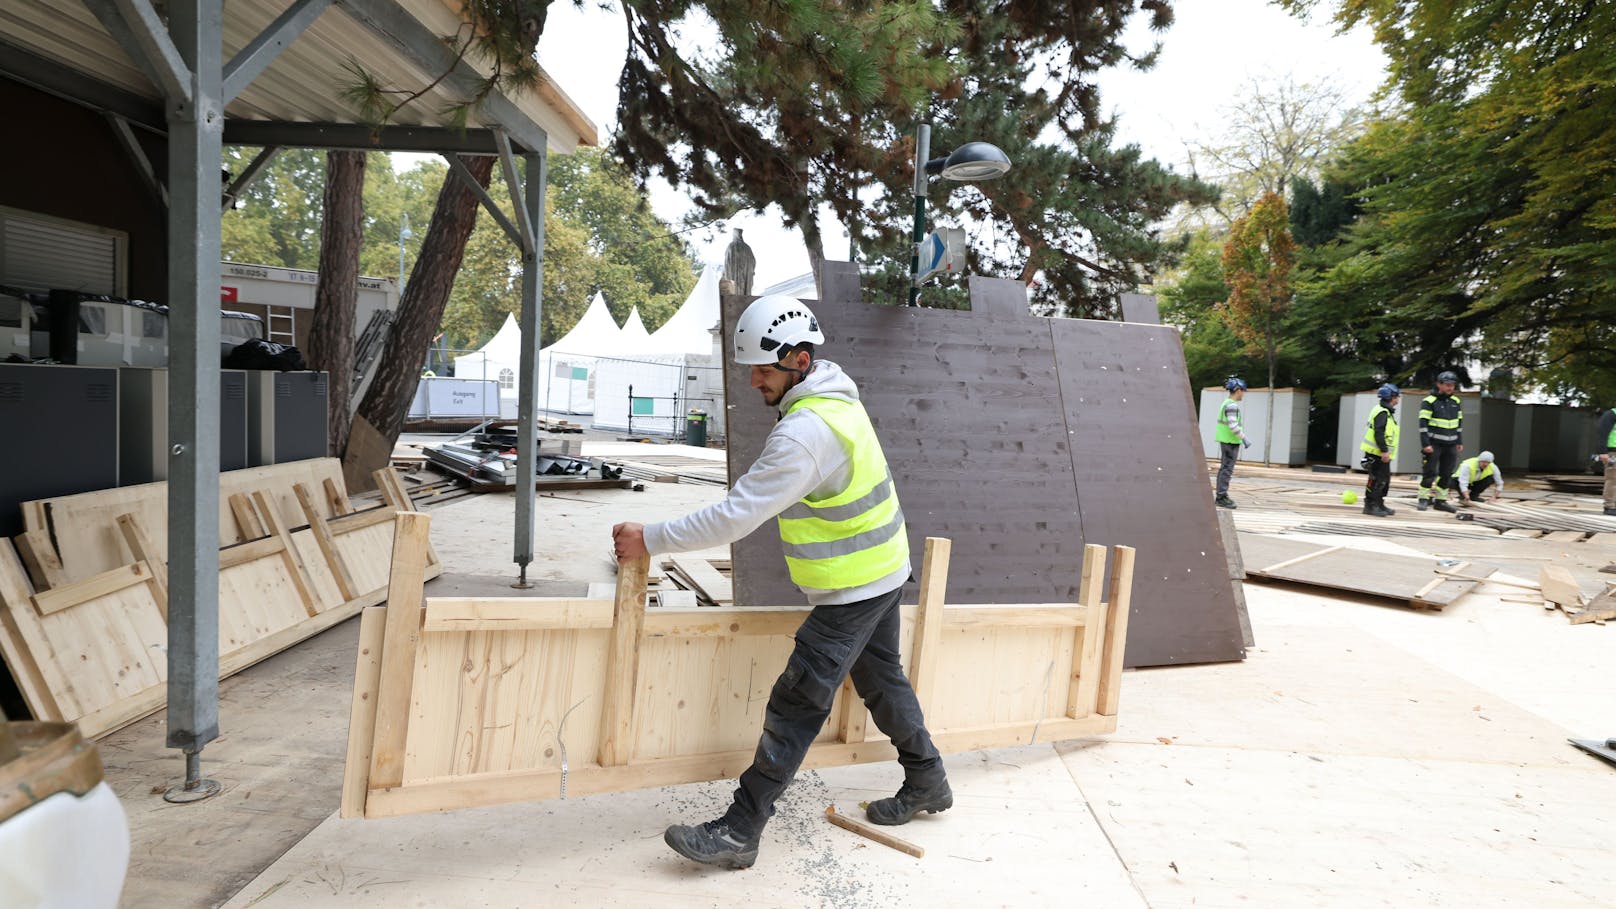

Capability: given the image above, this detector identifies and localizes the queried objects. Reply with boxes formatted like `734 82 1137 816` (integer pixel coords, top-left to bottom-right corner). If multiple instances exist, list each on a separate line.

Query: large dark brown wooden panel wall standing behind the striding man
722 262 1244 666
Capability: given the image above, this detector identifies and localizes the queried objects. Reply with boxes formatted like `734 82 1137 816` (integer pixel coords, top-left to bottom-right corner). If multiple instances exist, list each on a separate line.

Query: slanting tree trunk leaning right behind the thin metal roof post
343 155 494 488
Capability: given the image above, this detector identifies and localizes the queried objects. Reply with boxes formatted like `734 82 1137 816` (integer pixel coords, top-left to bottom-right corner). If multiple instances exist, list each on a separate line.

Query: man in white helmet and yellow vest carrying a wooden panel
612 296 953 869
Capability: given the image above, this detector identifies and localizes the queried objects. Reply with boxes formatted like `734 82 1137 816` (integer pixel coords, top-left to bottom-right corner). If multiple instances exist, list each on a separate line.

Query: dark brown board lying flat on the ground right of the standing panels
1239 534 1493 610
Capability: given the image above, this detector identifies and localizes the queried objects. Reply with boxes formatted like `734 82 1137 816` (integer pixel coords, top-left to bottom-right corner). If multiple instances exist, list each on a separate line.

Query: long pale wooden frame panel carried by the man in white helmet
343 527 1133 817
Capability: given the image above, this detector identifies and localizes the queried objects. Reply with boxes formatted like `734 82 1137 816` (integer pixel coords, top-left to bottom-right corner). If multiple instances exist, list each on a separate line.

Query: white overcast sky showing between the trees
538 0 1385 290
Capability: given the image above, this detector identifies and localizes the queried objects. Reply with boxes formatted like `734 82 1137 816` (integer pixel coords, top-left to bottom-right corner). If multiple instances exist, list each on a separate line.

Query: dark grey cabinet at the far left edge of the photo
0 364 118 537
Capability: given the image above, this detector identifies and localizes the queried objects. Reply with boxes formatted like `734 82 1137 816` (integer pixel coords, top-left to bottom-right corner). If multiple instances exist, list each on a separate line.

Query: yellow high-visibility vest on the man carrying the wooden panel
779 396 908 590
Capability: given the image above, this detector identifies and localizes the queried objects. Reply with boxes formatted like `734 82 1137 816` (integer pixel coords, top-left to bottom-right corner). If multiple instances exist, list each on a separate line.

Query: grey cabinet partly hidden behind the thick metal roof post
118 367 247 485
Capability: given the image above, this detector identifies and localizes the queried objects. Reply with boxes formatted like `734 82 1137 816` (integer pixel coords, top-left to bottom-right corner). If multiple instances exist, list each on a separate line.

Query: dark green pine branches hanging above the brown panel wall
614 0 1212 315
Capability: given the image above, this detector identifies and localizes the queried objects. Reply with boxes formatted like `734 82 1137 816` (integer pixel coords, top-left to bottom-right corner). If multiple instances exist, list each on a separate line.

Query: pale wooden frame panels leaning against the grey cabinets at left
0 463 442 736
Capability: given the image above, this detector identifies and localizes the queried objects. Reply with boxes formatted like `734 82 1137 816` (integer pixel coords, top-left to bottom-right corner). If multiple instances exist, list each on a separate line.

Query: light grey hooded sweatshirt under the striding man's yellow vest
645 359 910 607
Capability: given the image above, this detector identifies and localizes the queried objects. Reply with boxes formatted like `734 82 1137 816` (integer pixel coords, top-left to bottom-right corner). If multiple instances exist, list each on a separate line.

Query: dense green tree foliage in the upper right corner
1288 0 1616 400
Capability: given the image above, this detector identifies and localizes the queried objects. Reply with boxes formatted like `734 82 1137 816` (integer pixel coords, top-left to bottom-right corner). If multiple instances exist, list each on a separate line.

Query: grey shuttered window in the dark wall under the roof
0 207 129 296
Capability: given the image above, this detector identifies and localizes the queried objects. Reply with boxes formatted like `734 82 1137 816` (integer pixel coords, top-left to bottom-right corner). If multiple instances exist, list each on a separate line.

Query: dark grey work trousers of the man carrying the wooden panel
724 587 944 836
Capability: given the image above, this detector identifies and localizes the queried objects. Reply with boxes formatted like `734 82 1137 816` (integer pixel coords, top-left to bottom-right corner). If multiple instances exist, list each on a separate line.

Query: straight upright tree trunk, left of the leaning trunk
309 152 365 453
